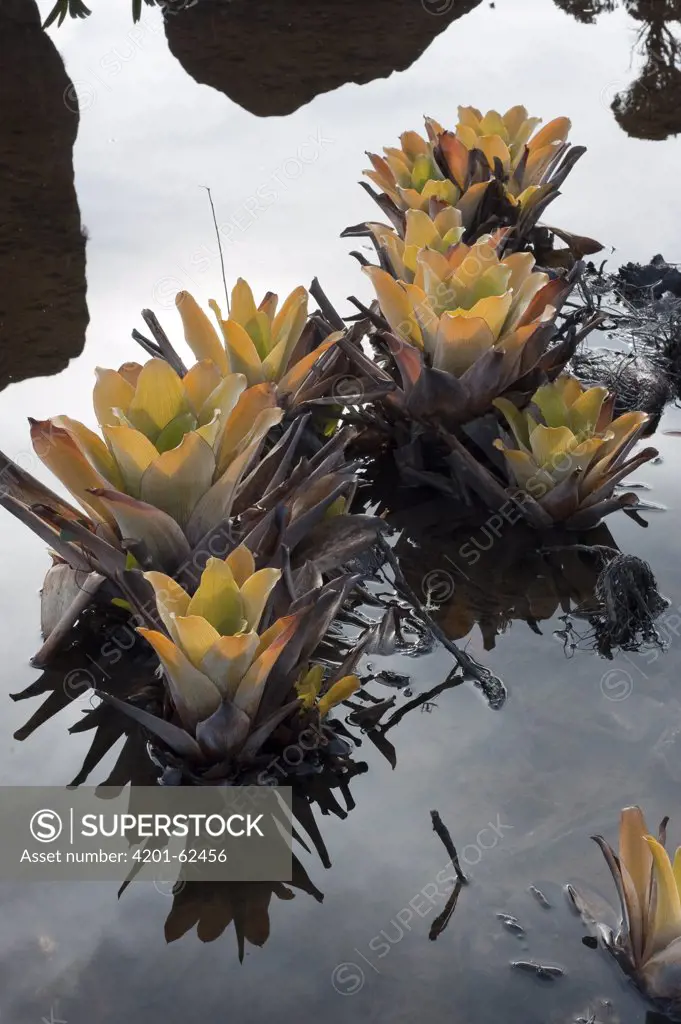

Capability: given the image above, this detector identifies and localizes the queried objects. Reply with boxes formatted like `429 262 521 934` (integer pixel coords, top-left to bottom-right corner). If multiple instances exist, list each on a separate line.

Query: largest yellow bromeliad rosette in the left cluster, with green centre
31 358 283 544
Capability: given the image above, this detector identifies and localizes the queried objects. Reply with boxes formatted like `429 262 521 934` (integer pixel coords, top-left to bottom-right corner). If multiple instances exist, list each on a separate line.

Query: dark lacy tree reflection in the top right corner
555 0 681 141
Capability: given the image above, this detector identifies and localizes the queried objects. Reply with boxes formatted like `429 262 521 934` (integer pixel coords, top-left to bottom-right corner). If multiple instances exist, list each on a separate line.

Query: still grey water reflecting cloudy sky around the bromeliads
0 0 681 1024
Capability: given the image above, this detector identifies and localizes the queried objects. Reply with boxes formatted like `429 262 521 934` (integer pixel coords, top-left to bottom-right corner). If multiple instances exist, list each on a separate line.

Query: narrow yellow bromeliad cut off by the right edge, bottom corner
568 807 681 1014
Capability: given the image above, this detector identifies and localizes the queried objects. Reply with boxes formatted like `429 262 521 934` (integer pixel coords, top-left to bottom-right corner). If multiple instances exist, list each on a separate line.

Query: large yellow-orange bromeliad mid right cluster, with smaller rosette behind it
358 229 579 430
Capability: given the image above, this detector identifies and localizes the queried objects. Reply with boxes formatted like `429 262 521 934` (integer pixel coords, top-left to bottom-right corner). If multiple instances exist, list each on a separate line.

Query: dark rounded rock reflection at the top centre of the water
165 0 480 117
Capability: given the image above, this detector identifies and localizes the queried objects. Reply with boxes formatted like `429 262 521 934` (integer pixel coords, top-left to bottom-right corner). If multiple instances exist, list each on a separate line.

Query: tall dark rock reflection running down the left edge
0 0 88 388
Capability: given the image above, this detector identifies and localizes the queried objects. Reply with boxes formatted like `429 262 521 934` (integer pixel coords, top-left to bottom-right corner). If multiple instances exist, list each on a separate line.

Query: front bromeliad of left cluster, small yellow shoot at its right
102 545 359 779
